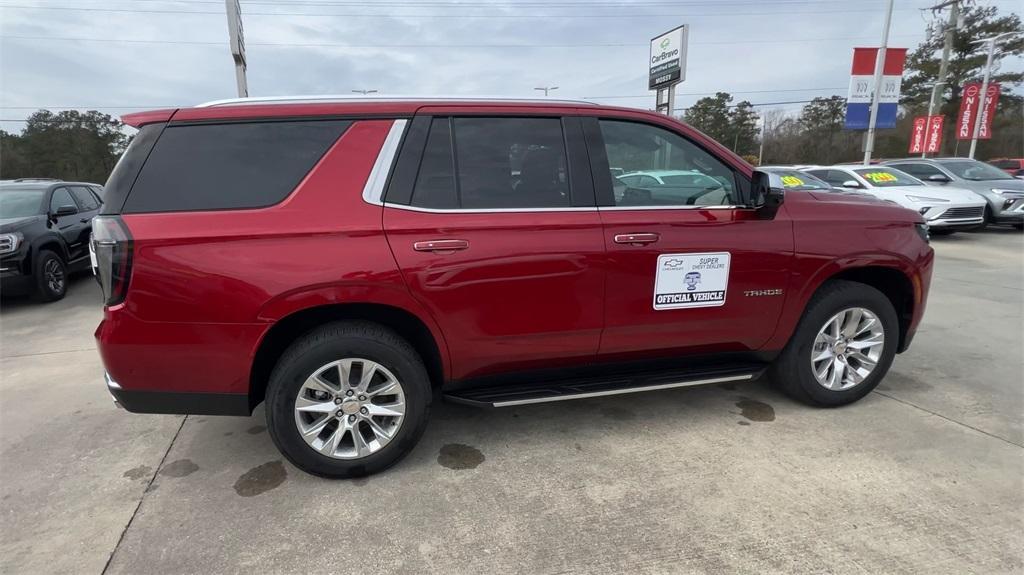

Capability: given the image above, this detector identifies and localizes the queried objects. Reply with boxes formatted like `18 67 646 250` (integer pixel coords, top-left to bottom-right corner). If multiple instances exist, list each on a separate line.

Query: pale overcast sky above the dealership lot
0 0 1021 131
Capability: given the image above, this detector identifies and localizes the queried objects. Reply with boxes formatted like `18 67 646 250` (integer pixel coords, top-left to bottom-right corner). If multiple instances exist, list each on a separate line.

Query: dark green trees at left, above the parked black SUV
0 109 129 183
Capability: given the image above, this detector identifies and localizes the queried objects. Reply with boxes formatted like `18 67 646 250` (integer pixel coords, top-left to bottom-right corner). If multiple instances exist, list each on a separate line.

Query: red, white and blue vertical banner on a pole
845 48 906 130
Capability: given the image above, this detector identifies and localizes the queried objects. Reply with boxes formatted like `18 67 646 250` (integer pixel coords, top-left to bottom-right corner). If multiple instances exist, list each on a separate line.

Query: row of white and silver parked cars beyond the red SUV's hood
765 158 1024 234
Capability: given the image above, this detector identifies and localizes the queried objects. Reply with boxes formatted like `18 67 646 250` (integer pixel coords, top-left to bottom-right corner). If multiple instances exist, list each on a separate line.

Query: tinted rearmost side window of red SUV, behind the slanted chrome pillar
124 120 351 213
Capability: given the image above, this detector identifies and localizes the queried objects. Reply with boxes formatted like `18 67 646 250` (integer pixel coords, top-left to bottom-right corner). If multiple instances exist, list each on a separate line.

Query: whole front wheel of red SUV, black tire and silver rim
771 280 899 406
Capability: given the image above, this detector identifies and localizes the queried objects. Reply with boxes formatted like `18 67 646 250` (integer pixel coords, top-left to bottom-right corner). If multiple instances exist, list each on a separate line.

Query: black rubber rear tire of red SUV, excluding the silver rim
266 321 432 478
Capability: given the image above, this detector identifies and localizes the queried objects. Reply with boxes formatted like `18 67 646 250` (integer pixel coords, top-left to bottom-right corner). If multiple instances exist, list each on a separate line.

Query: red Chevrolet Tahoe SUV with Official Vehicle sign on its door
92 98 933 477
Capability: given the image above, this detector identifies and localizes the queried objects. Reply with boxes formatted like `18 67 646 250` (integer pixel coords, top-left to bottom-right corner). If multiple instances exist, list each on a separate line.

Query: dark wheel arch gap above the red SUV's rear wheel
249 302 450 408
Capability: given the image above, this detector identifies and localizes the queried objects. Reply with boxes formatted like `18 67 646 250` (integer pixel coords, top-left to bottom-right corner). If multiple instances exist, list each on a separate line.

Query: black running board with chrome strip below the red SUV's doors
444 365 764 407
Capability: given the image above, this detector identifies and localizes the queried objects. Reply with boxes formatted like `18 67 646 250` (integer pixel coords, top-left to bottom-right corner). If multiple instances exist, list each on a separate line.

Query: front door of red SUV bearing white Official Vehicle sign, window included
585 118 794 359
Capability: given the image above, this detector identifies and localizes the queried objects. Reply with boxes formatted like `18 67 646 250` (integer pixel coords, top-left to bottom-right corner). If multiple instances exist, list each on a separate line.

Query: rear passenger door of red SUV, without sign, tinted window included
384 113 604 380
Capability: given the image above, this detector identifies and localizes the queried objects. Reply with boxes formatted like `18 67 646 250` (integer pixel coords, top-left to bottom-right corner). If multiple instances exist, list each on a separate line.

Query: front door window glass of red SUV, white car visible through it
599 120 739 207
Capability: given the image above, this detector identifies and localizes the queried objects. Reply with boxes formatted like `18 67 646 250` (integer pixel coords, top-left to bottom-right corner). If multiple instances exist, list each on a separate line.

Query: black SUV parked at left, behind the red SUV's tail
0 178 102 302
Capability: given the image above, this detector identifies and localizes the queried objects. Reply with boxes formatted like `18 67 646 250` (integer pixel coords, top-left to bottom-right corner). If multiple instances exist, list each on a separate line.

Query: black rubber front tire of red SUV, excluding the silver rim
769 280 899 407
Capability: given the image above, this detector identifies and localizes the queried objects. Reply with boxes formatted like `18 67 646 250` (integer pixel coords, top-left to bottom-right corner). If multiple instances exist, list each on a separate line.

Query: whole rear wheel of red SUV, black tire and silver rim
266 321 431 478
